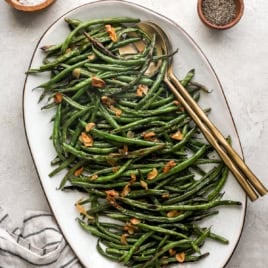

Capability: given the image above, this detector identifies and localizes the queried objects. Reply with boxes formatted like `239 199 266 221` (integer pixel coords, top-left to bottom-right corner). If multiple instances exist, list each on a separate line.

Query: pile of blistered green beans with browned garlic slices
29 17 241 268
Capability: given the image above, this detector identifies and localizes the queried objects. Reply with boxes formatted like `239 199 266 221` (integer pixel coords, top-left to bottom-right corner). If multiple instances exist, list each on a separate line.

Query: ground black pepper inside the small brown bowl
202 0 236 26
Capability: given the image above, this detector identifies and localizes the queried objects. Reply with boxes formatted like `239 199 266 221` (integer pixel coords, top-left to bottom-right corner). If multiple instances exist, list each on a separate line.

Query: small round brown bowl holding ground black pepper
197 0 244 30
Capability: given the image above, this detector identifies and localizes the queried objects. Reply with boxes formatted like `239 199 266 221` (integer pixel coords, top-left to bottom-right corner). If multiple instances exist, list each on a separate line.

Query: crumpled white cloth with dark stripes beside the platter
0 207 82 268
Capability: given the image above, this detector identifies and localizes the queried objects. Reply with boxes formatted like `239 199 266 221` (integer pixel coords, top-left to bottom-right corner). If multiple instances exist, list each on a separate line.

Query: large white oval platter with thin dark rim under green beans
23 0 246 268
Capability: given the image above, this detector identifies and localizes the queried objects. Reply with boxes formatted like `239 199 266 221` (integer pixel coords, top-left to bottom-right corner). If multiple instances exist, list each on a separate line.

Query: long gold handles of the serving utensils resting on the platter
164 67 267 201
